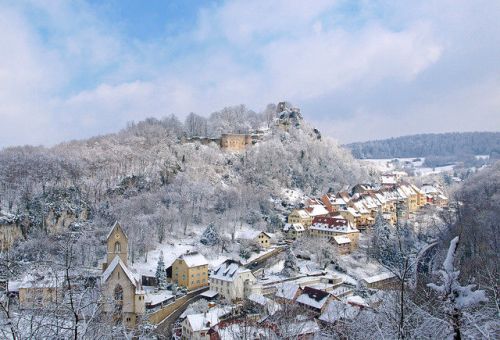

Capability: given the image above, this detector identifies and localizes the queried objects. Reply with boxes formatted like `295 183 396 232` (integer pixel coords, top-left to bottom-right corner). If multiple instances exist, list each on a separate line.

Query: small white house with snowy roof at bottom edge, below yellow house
181 311 220 340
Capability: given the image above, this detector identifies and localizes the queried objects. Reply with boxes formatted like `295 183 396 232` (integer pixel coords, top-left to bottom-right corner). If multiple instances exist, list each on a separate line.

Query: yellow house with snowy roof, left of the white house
172 252 209 290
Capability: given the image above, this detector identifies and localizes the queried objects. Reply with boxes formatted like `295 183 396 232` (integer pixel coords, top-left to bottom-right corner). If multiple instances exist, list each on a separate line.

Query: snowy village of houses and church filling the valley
0 163 448 339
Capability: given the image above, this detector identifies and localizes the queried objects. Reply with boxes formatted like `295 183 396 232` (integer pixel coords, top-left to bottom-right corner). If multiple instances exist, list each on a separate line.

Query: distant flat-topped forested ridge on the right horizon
345 132 500 163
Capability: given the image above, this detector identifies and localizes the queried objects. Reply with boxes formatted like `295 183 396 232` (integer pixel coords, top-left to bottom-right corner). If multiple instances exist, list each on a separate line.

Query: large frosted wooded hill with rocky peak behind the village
0 103 367 263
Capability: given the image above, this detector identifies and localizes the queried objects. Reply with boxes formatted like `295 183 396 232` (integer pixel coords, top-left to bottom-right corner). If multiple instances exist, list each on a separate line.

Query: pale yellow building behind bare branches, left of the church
16 271 65 309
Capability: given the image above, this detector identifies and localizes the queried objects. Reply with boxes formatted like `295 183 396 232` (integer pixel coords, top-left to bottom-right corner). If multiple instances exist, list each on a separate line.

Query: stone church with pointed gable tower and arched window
101 222 146 328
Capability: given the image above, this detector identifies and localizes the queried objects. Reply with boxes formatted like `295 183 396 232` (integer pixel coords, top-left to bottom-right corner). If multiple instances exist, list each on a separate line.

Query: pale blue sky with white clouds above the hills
0 0 500 147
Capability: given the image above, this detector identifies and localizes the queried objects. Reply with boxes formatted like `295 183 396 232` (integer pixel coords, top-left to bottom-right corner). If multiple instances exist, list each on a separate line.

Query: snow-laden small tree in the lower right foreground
428 236 488 340
